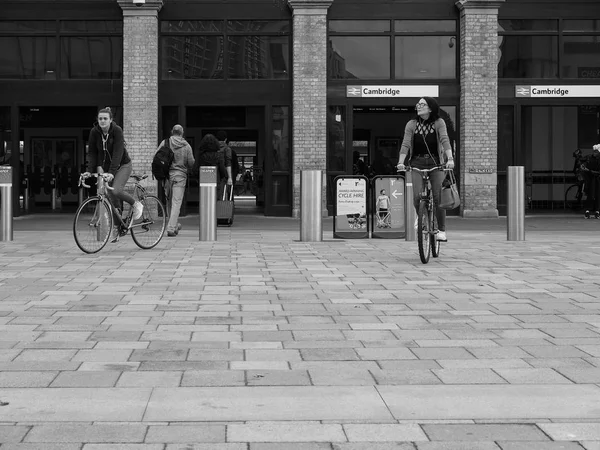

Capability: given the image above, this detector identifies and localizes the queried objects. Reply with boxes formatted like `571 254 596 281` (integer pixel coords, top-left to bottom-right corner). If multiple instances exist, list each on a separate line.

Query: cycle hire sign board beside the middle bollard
333 175 369 239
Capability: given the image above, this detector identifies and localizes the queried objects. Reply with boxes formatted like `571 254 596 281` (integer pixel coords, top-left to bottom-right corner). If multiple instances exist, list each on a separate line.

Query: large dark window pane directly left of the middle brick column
228 36 290 80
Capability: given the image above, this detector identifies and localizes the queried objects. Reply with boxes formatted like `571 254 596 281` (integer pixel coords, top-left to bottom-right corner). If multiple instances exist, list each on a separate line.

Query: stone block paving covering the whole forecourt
0 216 600 450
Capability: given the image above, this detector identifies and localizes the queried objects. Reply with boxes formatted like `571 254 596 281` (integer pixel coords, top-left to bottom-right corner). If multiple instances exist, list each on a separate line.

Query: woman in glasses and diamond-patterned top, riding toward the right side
396 97 454 242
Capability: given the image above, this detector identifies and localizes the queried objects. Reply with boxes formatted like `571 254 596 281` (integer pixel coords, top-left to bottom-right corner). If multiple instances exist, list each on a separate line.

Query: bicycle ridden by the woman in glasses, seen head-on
398 165 450 264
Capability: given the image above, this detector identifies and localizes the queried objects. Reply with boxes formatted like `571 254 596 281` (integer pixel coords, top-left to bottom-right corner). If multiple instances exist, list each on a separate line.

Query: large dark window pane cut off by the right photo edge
561 36 600 78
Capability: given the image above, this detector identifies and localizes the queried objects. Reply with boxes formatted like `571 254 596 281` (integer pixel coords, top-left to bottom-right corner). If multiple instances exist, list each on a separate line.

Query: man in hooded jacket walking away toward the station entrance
158 125 196 237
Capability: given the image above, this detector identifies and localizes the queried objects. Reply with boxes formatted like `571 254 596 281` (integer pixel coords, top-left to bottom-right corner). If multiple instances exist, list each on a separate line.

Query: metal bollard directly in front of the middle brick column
300 170 323 242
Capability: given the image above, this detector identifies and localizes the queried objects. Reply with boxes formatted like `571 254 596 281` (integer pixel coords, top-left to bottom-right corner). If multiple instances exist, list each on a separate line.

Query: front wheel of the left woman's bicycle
73 197 113 253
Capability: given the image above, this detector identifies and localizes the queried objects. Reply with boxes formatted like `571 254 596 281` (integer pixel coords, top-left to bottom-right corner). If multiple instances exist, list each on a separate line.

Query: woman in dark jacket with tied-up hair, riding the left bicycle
85 107 144 242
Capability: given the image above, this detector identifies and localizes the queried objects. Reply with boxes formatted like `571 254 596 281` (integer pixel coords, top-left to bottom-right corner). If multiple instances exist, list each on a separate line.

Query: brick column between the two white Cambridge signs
456 0 504 217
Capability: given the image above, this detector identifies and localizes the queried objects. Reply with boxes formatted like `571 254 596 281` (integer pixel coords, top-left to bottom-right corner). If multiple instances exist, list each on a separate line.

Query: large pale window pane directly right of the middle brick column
329 36 390 80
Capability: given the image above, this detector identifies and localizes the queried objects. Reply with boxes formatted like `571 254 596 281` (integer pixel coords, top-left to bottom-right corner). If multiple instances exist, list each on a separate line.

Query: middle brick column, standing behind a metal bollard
288 0 333 217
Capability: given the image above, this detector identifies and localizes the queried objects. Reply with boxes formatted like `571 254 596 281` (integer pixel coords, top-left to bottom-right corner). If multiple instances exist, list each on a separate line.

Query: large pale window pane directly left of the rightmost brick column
395 36 456 79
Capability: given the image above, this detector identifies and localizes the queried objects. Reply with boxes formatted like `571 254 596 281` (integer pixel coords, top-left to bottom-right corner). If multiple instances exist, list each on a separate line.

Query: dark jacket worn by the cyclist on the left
88 122 131 175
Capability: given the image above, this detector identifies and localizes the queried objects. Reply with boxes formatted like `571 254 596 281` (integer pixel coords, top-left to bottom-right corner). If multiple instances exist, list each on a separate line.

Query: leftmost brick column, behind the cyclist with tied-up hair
117 0 163 190
